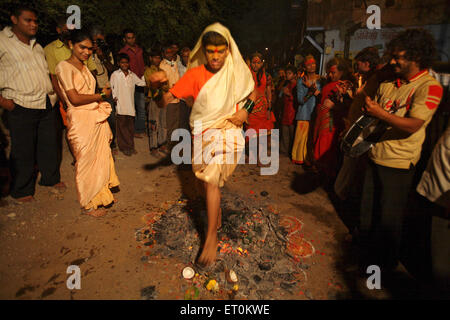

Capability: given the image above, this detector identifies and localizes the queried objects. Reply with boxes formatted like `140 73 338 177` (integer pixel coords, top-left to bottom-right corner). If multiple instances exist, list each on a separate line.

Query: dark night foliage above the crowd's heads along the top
0 0 307 69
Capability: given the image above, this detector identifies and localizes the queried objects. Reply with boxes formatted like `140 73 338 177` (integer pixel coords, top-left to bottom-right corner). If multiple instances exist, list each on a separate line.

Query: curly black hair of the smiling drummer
387 29 437 69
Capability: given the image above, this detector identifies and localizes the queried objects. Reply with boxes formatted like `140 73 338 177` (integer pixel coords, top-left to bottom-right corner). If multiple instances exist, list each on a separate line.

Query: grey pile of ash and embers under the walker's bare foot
136 190 308 299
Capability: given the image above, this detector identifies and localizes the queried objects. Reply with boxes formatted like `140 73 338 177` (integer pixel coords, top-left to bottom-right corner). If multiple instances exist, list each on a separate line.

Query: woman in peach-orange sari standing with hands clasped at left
56 30 119 217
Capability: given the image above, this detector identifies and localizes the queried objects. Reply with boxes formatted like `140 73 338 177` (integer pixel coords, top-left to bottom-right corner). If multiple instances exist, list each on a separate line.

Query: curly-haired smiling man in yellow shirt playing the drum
359 29 442 272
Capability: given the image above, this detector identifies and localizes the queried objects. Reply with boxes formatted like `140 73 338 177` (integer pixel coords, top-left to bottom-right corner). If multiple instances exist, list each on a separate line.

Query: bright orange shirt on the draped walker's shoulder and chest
169 64 214 100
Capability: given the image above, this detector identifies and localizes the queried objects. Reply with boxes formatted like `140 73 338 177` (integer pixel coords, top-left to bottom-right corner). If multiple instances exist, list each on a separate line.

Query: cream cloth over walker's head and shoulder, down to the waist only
188 23 255 134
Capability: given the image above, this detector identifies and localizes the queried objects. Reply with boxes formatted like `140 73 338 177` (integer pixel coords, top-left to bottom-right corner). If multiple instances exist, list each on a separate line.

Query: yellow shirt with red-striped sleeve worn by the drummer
369 70 442 169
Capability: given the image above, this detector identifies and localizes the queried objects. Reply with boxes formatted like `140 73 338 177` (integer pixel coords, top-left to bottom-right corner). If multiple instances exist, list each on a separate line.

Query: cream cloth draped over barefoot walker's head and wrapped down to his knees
188 23 255 187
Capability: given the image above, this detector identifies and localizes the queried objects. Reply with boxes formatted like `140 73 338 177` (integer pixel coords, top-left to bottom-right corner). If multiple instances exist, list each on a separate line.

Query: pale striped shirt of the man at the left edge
0 27 56 109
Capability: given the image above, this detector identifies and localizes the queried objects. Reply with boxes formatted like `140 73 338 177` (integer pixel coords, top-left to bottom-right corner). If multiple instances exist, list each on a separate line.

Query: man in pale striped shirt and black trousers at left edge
0 6 65 202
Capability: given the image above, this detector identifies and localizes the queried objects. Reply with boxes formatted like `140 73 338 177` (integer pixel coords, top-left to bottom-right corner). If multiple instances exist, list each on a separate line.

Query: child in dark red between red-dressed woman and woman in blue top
280 65 298 154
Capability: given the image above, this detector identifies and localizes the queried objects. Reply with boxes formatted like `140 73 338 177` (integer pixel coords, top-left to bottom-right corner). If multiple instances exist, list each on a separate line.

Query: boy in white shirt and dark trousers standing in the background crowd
110 53 146 156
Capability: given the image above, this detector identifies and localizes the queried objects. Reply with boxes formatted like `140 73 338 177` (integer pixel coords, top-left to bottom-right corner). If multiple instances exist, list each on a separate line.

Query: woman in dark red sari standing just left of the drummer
314 58 354 180
